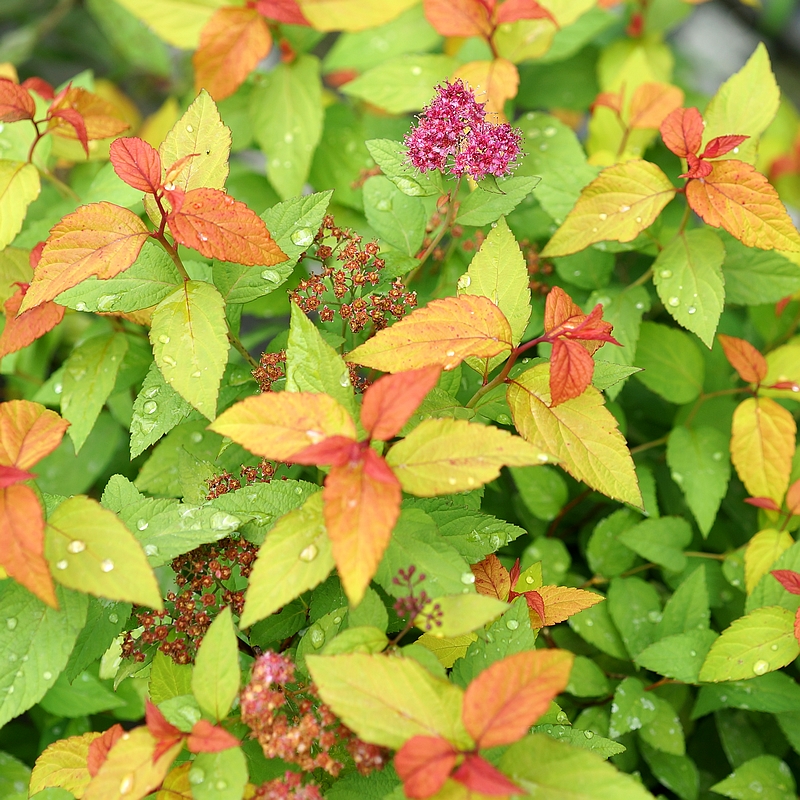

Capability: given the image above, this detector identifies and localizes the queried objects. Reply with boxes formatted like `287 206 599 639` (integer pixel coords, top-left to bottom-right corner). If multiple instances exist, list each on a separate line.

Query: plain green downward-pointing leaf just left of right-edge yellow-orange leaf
667 425 731 536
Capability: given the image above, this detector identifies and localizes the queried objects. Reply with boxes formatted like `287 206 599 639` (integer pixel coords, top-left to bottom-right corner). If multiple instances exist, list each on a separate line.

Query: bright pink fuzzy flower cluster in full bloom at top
404 79 522 181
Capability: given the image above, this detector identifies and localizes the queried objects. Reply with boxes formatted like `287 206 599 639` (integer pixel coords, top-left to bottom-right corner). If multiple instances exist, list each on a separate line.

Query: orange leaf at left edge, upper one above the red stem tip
0 400 69 469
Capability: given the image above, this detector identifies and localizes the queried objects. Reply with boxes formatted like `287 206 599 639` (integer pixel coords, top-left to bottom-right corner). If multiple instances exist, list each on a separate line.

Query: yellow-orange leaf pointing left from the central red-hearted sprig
209 392 356 461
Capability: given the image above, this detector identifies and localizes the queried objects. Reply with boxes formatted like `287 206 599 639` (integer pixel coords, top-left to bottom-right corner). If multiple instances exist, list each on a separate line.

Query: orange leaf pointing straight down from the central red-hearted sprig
322 449 402 606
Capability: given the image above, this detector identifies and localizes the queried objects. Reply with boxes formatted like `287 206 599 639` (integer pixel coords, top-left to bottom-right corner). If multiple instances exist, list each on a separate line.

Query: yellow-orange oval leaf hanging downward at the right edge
731 397 797 504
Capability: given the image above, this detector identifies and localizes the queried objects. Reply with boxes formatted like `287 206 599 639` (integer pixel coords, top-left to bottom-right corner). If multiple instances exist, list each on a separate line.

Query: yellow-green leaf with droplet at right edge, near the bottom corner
700 606 800 683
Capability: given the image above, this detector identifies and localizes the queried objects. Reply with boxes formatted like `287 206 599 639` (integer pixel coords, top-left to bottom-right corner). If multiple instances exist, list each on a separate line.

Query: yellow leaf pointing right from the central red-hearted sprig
386 418 549 497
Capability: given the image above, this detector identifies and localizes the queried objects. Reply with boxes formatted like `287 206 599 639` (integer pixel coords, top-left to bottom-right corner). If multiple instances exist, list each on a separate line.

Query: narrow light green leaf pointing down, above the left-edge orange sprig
61 333 128 453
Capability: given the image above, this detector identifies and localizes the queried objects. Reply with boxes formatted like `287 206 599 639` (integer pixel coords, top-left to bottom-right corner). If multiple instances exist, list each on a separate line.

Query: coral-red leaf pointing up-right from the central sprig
361 366 442 441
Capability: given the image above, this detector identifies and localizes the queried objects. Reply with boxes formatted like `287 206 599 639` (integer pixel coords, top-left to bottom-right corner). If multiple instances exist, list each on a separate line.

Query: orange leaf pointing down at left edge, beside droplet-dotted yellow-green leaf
0 482 58 608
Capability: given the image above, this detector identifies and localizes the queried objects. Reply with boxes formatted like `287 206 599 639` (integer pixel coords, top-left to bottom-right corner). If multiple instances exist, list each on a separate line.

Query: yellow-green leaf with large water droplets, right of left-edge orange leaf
45 495 164 609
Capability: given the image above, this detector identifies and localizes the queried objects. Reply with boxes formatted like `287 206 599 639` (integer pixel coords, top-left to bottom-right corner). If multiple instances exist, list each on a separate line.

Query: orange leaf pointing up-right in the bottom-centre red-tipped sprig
461 650 574 748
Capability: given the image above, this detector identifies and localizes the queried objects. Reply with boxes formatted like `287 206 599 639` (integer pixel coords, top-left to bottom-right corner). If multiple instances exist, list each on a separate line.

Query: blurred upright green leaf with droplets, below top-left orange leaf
250 55 323 198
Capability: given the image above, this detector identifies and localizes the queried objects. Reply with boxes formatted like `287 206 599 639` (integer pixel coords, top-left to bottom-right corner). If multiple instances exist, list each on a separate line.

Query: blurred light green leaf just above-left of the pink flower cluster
341 55 456 114
